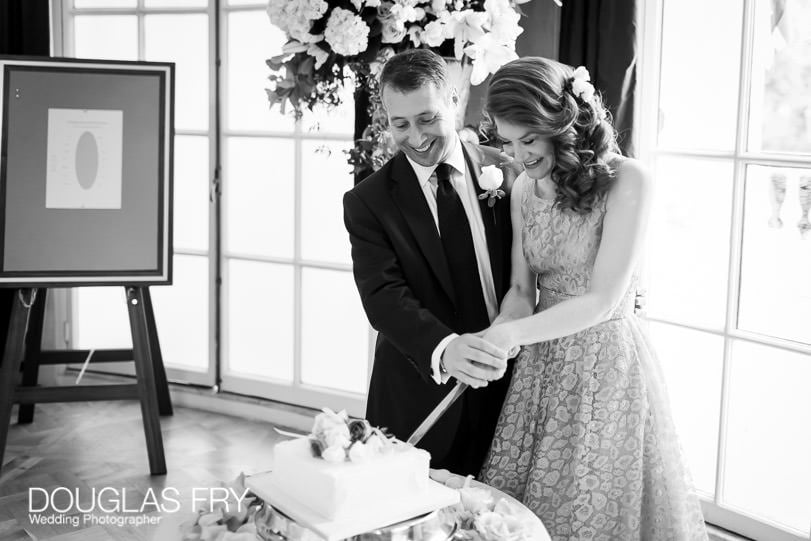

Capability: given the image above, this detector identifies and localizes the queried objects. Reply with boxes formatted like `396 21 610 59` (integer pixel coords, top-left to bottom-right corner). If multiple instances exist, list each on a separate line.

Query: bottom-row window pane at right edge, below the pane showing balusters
724 341 811 535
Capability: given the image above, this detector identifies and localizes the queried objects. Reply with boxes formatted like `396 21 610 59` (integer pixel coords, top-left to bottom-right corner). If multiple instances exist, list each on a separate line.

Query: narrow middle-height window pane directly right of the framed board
173 135 209 250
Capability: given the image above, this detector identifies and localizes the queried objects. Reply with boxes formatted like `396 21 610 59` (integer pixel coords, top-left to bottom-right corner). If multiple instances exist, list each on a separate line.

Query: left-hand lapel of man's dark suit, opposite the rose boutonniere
391 152 456 299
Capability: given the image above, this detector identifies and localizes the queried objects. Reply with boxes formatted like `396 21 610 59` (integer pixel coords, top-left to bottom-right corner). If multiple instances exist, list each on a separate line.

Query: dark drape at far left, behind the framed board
0 0 51 370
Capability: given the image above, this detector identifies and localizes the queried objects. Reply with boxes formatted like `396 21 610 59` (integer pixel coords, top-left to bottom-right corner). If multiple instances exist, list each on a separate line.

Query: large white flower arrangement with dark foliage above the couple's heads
267 0 544 171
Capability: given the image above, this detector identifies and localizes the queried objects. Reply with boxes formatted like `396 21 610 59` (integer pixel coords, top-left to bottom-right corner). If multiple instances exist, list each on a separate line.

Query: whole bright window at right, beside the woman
640 0 811 540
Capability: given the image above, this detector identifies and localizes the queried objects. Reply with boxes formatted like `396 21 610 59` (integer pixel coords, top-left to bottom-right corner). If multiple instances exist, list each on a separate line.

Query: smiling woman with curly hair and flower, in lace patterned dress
482 58 707 541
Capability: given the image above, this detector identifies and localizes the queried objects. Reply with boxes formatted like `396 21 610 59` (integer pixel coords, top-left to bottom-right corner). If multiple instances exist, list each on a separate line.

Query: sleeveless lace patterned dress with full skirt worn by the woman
482 171 707 541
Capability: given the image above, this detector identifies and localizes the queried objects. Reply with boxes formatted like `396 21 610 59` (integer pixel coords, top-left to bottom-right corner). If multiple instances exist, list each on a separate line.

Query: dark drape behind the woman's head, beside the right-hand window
559 0 637 156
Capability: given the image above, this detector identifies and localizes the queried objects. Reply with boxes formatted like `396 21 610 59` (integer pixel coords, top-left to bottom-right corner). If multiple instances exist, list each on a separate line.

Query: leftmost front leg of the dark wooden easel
0 289 37 470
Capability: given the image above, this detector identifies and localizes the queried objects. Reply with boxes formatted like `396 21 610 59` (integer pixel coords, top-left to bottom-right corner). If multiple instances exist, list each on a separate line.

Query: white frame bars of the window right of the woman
634 0 811 541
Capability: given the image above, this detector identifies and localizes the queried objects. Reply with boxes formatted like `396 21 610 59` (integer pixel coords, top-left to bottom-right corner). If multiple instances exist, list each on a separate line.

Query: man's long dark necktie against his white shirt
436 163 490 333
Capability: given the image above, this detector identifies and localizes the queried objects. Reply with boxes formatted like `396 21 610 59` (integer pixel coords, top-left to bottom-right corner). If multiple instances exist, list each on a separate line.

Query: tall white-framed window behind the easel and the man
61 0 373 415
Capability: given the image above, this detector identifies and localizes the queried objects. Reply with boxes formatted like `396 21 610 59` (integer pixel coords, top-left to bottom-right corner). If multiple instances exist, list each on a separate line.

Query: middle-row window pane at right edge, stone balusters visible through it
738 166 811 344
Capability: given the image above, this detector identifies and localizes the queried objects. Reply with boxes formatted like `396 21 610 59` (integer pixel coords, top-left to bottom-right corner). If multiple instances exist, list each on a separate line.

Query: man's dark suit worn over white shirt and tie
344 143 512 474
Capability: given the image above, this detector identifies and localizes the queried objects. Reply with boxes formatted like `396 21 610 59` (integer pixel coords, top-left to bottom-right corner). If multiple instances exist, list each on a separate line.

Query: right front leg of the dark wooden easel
125 287 166 475
